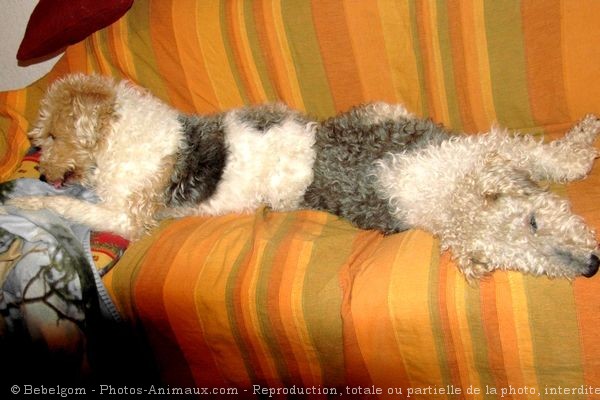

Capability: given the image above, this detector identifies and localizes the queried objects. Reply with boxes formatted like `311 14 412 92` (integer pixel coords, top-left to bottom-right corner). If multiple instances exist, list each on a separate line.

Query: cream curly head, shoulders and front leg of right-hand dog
377 116 600 279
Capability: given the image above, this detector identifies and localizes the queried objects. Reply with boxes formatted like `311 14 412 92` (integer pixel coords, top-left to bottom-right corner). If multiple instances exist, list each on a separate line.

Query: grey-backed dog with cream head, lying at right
302 103 600 281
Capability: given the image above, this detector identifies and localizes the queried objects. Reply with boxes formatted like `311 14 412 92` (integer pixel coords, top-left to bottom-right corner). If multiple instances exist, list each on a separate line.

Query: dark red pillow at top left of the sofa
17 0 133 61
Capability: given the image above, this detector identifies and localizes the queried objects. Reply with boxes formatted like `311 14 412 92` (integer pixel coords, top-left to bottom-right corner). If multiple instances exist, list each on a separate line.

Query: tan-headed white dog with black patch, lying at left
11 74 316 240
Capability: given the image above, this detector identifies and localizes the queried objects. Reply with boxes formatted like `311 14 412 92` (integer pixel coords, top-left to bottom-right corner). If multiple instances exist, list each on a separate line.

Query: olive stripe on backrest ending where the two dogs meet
282 0 335 118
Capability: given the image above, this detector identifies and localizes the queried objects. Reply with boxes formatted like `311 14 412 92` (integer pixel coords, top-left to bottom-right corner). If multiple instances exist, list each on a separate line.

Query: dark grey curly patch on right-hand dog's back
303 105 450 234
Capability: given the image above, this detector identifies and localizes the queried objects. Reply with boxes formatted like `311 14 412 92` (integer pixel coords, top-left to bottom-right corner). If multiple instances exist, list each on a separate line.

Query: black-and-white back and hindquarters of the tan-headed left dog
166 104 316 215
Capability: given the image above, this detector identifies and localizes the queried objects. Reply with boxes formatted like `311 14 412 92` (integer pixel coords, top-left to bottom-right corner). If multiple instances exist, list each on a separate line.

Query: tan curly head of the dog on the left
29 74 116 186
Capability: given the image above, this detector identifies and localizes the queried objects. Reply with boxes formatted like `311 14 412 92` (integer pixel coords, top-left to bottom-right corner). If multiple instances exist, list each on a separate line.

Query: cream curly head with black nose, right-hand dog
450 154 599 278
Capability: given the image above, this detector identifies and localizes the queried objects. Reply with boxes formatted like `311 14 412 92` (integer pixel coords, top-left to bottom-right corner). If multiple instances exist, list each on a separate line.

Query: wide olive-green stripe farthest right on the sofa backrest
484 0 534 128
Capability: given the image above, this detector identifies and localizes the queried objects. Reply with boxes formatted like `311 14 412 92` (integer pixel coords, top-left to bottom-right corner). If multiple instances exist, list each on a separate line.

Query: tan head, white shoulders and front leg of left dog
13 74 181 239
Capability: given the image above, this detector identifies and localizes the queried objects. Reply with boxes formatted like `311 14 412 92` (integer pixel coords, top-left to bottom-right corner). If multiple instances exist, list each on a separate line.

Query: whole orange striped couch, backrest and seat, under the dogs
0 0 600 399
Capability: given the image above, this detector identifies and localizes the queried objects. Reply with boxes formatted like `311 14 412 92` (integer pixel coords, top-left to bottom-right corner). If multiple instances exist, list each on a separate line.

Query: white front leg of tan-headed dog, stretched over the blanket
5 196 135 238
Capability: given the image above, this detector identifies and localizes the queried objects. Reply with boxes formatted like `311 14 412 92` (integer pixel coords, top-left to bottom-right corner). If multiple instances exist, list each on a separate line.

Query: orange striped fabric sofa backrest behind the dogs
0 0 600 178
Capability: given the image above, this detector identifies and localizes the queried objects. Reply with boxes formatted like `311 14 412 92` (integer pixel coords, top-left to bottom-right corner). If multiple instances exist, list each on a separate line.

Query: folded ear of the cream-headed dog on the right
474 152 542 202
